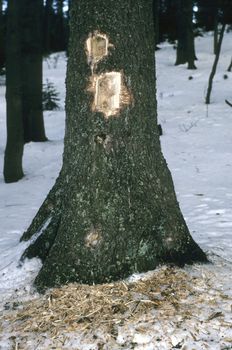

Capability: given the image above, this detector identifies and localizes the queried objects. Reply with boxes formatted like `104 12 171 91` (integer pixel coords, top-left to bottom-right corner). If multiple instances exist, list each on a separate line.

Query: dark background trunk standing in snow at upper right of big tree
175 0 196 69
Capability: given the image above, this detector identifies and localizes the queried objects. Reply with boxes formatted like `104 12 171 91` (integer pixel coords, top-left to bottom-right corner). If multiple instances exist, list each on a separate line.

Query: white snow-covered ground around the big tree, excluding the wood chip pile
0 33 232 350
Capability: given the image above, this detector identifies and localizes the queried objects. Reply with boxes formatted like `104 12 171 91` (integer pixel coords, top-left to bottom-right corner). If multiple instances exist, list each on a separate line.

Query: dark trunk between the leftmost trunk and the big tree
20 0 47 142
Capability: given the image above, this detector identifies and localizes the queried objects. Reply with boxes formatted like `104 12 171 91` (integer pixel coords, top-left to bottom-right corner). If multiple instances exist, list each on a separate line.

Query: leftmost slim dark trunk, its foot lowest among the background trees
3 0 24 182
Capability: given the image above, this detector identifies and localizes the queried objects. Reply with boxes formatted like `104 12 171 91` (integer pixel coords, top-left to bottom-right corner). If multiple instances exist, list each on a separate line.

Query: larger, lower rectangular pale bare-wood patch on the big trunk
88 72 132 119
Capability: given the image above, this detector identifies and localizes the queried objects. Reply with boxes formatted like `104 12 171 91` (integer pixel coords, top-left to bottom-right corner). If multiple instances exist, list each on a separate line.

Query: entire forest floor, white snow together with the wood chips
0 32 232 350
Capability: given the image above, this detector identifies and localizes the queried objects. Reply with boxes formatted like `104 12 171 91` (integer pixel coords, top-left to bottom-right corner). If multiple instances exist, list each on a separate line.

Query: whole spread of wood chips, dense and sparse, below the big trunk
0 265 232 350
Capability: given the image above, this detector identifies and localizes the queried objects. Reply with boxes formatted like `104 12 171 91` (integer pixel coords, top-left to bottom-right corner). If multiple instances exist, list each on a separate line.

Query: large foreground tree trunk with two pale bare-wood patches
22 0 207 290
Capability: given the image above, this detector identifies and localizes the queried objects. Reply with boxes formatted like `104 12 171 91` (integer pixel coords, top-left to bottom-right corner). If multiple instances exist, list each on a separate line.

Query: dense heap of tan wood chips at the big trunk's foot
4 267 193 337
